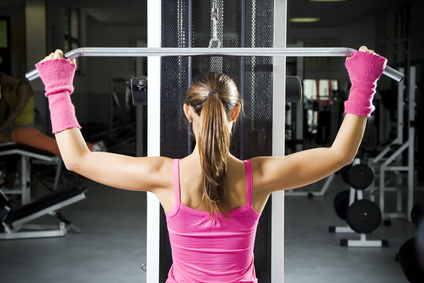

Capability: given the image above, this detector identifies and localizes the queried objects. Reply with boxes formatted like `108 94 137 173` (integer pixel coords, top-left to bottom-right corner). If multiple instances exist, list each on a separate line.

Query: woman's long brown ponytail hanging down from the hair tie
197 92 230 217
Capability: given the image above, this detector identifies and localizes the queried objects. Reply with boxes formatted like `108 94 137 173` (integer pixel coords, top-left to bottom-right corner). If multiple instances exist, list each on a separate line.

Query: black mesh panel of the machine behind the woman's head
160 0 273 282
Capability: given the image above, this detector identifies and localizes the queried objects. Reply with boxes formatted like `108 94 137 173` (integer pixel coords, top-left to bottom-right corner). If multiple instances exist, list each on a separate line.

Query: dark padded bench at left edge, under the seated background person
0 143 63 205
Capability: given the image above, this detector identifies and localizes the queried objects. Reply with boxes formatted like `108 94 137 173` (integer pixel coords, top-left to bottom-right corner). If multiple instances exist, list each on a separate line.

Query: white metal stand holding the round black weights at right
329 158 388 247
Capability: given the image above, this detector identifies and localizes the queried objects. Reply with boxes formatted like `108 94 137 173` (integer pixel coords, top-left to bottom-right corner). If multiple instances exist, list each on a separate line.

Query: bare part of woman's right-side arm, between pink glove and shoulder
251 114 367 194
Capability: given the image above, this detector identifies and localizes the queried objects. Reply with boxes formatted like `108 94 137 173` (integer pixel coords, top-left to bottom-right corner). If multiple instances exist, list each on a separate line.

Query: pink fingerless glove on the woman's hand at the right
345 51 387 117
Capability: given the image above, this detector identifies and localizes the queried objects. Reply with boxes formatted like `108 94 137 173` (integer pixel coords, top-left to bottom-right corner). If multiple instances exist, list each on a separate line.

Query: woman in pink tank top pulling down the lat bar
36 47 386 282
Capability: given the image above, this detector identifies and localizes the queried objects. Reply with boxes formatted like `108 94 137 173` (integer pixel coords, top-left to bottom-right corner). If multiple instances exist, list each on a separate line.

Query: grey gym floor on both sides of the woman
0 172 424 283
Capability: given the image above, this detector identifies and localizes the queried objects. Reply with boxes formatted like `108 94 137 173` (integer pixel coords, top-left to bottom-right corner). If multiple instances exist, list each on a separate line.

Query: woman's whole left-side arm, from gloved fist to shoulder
36 50 173 192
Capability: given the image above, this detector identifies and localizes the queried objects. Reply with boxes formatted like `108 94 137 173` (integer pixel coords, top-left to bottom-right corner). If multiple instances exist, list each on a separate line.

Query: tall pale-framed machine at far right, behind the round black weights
368 66 416 221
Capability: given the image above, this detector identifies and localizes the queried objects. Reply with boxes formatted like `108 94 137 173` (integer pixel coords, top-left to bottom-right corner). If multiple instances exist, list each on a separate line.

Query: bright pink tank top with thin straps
165 159 260 283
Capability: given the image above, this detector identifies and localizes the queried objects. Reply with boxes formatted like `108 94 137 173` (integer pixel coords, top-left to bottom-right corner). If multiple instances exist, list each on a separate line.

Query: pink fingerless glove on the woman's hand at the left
35 59 81 134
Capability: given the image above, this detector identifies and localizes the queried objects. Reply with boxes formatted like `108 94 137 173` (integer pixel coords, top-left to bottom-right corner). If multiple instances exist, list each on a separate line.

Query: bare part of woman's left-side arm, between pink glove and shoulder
55 128 172 192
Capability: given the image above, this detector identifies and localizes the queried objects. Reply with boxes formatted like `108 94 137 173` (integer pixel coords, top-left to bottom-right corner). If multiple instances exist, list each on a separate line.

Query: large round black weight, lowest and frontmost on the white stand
346 199 381 234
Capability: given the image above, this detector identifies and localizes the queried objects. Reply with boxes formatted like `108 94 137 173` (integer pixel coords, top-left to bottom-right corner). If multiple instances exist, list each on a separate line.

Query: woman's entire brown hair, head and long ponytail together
186 73 241 217
